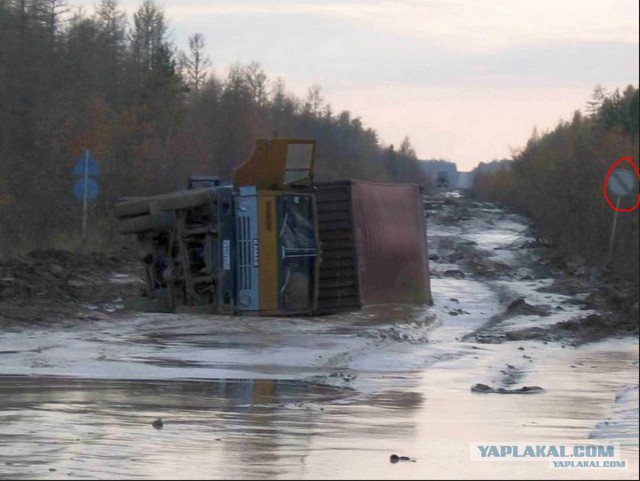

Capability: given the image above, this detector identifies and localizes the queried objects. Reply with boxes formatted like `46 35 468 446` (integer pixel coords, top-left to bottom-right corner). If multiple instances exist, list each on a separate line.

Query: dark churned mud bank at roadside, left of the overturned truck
0 250 143 326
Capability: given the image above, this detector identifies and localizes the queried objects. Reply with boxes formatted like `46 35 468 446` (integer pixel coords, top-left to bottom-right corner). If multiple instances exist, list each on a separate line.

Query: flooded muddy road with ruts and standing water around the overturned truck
0 196 638 479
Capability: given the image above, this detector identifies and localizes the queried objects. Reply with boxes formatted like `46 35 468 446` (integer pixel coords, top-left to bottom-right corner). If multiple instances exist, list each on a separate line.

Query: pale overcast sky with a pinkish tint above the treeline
67 0 640 170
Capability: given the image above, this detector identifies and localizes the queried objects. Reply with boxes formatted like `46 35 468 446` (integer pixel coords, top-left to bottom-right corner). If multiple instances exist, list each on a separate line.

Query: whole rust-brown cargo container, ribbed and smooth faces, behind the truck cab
304 180 431 313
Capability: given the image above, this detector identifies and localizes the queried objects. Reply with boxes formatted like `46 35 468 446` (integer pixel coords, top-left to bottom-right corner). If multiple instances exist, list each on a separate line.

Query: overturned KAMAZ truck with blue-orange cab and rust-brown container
115 138 431 316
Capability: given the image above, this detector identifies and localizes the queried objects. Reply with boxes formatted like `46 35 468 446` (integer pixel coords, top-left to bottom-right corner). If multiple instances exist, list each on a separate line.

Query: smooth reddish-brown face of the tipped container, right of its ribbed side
351 181 431 305
